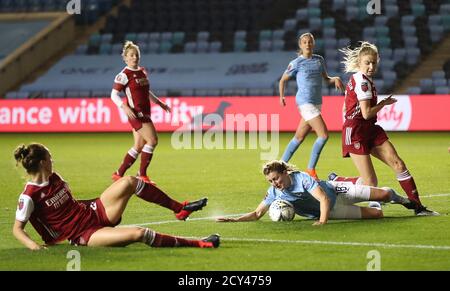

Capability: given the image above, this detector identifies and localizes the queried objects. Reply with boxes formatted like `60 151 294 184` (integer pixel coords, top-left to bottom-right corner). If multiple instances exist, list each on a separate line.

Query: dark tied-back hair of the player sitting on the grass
14 143 48 174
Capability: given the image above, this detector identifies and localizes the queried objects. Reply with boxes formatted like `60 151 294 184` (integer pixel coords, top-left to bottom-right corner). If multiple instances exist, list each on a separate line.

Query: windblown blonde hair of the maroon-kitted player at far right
339 41 380 73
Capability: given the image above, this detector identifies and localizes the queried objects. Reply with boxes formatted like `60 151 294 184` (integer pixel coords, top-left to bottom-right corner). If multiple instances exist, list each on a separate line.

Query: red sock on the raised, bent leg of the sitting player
136 179 183 213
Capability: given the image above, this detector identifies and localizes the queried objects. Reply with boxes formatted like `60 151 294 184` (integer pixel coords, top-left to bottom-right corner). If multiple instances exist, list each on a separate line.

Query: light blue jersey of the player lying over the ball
263 172 336 218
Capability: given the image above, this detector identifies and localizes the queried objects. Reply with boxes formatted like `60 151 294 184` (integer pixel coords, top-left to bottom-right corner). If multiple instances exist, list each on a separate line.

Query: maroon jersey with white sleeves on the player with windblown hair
345 72 378 124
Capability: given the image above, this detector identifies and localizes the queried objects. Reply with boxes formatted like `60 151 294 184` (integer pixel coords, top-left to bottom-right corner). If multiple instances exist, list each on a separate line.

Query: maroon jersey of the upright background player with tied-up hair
113 67 150 118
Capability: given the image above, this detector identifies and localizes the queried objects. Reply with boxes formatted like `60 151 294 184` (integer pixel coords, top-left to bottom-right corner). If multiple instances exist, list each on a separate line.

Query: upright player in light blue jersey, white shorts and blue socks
279 32 344 179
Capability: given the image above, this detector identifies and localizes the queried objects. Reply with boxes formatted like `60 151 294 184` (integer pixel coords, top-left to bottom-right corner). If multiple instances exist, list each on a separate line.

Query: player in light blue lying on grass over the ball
217 161 415 225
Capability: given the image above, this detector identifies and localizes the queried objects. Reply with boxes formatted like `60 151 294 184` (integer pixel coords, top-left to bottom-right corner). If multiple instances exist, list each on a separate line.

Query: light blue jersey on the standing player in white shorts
285 55 325 105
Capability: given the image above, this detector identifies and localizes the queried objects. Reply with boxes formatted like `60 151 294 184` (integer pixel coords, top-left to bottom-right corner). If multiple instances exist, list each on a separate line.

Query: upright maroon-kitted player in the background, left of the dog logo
111 41 171 183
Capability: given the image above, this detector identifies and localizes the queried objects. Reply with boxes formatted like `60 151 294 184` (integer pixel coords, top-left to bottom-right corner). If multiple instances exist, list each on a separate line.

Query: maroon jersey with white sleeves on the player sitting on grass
16 173 102 244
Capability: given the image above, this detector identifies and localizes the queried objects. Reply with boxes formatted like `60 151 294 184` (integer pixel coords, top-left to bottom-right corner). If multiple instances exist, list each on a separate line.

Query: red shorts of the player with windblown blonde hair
342 121 389 158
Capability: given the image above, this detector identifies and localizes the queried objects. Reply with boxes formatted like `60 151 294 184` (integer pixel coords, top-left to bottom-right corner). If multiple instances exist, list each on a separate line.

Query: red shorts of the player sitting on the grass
69 198 120 246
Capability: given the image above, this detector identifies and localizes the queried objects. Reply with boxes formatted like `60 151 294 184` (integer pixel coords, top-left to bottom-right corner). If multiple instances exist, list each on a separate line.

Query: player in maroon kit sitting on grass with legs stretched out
13 143 220 250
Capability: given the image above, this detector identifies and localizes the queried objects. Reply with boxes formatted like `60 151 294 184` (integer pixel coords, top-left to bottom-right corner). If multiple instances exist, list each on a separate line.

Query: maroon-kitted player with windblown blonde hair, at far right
341 42 439 216
